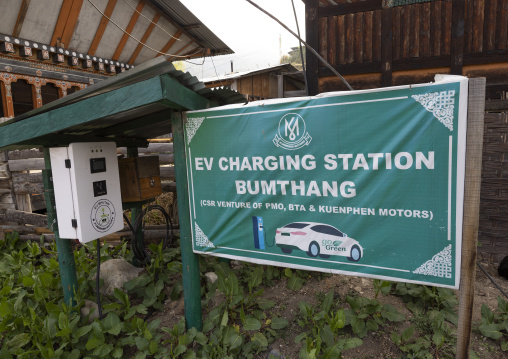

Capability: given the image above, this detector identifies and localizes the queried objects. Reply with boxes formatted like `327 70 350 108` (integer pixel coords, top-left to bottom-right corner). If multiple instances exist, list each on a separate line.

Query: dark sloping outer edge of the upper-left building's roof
150 0 234 55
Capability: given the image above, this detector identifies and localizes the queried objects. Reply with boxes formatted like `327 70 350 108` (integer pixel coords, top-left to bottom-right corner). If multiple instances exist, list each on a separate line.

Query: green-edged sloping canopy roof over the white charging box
0 58 245 150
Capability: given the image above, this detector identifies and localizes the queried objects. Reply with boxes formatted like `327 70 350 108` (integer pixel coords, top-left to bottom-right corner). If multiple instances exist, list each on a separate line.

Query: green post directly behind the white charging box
43 147 78 306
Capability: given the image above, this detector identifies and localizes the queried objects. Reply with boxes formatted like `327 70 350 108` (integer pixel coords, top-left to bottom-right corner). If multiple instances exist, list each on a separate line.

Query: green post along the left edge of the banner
171 113 203 330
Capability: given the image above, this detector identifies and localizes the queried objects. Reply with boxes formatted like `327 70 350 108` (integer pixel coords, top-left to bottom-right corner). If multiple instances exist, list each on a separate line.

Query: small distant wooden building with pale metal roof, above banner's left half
201 64 306 101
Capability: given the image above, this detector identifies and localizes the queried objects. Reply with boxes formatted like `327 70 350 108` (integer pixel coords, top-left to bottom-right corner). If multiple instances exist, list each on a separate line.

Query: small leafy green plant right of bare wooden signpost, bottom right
478 297 508 351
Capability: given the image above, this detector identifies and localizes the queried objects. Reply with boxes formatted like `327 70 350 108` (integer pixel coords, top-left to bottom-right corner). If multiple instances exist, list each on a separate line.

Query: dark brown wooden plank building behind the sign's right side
304 0 508 262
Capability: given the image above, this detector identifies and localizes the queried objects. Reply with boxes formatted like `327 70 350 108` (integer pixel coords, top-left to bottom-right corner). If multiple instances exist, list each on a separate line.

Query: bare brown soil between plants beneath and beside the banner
154 256 508 359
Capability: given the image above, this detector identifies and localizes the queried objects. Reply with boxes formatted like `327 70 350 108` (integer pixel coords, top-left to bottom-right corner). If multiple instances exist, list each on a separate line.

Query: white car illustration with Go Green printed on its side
275 222 363 262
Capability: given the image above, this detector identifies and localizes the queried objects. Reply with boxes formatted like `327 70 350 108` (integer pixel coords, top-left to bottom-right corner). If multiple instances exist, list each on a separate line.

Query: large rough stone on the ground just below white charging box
93 258 143 296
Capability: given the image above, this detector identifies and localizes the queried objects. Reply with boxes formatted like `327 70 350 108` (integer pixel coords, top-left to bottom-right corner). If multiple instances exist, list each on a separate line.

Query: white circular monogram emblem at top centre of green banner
273 113 312 150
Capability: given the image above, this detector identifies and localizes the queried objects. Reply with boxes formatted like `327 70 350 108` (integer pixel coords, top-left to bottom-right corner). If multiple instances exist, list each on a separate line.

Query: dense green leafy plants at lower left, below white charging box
0 233 179 359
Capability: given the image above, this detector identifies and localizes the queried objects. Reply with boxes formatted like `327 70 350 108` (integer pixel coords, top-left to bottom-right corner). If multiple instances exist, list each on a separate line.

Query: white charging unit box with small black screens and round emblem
50 142 124 243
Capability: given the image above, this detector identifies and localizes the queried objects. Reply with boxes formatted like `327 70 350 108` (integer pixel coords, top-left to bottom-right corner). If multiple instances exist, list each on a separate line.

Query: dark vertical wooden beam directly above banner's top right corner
450 0 465 75
